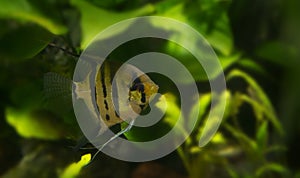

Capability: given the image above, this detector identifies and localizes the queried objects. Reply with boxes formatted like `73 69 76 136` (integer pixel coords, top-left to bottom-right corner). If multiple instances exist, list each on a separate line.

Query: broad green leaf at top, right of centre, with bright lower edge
157 1 233 56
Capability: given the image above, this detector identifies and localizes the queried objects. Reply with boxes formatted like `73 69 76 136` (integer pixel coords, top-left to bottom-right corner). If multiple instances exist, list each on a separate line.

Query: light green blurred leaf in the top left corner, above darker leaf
0 0 67 34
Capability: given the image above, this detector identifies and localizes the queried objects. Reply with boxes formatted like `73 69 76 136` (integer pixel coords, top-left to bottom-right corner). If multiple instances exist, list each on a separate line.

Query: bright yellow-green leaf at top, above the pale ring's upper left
71 0 154 48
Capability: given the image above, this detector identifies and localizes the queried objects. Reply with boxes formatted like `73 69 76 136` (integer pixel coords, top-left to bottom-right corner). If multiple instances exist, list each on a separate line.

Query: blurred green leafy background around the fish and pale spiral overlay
0 0 300 178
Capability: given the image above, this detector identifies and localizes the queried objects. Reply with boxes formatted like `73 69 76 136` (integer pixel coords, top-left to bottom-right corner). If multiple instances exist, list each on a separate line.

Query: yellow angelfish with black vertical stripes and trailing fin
44 58 159 160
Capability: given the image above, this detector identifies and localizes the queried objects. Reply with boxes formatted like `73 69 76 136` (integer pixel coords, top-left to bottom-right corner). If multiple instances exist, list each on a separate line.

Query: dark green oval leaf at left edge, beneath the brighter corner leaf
0 24 53 61
